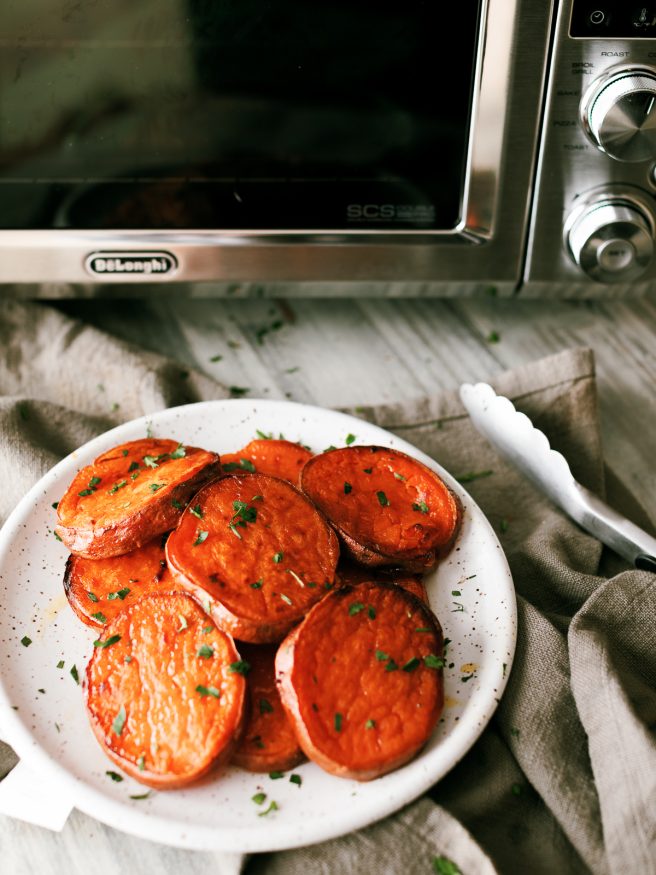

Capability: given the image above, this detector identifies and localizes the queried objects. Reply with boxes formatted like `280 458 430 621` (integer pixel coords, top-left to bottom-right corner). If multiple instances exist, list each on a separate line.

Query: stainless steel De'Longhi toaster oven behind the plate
0 0 656 295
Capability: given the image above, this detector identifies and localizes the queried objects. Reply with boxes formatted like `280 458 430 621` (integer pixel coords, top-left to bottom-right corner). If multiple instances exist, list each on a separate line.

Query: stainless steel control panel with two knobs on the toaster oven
524 0 656 296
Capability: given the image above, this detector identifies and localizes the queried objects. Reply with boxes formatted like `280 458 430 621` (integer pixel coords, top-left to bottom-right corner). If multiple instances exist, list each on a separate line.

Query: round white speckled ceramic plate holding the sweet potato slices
0 400 516 851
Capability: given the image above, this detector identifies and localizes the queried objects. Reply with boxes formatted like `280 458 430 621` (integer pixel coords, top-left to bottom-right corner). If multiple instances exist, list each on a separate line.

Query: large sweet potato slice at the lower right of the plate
276 583 444 781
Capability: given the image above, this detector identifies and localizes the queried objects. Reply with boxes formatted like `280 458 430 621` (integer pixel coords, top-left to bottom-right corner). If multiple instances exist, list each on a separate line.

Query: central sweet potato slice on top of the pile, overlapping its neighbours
166 474 339 644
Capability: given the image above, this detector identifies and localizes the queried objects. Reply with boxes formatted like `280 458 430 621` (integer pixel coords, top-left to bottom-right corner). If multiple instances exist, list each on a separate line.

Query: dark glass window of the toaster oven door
0 0 481 233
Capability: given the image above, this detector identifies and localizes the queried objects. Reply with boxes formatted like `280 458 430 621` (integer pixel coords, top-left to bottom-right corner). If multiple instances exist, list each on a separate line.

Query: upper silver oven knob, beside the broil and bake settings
581 69 656 161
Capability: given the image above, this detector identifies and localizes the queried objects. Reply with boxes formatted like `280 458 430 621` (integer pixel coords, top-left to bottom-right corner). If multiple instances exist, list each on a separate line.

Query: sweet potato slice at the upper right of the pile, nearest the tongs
301 446 461 572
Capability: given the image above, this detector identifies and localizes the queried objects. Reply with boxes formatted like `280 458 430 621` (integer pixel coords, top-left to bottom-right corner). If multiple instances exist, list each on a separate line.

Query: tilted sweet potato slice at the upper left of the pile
55 438 221 559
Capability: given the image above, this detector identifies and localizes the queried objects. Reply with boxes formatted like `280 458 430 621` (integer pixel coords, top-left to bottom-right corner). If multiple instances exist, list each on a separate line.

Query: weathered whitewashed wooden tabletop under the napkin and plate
0 298 656 875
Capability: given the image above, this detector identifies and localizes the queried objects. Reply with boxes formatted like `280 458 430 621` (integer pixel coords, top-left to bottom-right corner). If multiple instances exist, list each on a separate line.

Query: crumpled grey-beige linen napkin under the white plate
0 302 656 875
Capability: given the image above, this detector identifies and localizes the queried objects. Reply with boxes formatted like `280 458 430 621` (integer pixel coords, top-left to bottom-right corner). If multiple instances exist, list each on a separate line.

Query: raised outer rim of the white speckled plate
0 398 517 853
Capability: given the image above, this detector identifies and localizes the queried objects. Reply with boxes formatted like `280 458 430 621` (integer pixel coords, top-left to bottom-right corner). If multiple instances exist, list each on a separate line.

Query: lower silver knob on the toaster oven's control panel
566 199 654 283
